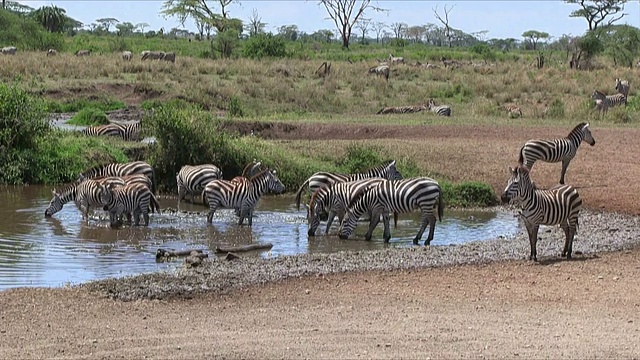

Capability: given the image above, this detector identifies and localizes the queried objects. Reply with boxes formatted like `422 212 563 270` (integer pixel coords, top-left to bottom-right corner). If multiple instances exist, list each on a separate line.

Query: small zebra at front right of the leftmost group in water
99 184 153 227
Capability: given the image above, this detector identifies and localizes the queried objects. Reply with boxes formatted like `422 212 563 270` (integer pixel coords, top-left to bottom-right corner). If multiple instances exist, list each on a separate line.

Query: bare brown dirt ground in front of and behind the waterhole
0 124 640 359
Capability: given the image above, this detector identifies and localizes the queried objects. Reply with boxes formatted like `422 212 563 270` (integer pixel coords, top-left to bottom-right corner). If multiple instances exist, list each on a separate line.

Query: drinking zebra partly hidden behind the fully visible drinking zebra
307 178 390 236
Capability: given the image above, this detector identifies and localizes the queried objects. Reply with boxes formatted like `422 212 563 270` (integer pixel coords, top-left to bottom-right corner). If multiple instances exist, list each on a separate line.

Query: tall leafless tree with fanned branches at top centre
318 0 386 49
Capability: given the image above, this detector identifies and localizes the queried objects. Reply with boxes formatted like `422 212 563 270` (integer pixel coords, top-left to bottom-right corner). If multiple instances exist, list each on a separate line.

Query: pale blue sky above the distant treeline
18 0 640 39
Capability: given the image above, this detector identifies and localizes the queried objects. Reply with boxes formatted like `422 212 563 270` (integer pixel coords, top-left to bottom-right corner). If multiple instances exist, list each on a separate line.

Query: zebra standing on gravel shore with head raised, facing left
500 166 582 261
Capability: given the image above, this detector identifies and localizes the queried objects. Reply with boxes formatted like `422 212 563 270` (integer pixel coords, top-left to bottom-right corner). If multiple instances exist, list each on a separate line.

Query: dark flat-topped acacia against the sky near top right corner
565 0 628 30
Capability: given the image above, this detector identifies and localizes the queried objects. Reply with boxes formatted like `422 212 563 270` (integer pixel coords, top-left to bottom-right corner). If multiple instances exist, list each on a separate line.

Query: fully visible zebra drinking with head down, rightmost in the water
339 177 443 245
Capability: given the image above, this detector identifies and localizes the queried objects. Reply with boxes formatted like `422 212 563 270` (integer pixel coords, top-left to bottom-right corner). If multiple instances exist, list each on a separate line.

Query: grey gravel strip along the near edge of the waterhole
78 205 640 301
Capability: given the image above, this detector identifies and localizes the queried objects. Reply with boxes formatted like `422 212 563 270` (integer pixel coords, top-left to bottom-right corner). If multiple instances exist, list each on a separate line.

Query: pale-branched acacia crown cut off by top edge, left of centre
160 0 238 32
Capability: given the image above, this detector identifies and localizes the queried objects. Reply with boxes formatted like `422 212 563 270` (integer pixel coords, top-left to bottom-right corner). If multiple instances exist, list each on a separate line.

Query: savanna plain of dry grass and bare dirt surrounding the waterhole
0 46 640 359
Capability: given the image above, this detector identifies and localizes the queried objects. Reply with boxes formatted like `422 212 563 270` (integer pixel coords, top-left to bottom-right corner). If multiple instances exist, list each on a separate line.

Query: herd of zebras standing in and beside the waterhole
45 122 595 261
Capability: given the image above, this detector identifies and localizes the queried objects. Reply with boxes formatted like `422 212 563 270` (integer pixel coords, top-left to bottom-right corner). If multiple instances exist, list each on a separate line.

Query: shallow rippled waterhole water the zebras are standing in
0 186 518 289
